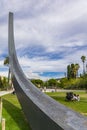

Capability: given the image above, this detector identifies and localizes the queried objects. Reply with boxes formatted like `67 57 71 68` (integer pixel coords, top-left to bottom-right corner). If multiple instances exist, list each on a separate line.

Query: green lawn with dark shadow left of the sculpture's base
0 94 31 130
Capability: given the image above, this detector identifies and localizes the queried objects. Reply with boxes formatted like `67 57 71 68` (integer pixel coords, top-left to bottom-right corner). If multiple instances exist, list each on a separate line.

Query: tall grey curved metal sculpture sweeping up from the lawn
8 12 87 130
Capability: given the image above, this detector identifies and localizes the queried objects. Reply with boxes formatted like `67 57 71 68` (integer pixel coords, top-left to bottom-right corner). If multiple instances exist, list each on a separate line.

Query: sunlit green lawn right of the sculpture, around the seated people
47 91 87 116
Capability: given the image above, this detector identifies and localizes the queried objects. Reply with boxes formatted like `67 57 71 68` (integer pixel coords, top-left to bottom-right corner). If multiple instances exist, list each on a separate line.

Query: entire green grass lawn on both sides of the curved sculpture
0 91 87 130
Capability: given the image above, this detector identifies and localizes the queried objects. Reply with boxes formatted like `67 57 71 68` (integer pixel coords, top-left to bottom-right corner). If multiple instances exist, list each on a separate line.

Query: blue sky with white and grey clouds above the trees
0 0 87 80
